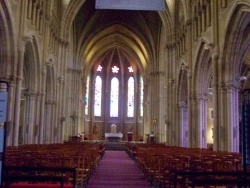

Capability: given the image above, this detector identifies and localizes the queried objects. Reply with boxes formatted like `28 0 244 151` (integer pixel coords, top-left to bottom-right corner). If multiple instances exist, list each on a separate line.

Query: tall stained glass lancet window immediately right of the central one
127 77 135 117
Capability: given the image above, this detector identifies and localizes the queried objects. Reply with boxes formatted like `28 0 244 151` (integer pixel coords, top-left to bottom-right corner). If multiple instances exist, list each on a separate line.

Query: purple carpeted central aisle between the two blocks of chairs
87 151 151 188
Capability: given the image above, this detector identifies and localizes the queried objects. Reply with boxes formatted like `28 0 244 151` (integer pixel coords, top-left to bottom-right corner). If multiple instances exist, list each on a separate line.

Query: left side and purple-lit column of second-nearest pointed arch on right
191 40 212 148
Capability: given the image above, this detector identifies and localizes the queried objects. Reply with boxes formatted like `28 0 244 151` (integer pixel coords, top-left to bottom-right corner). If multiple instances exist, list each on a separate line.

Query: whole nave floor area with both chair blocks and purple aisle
4 142 250 188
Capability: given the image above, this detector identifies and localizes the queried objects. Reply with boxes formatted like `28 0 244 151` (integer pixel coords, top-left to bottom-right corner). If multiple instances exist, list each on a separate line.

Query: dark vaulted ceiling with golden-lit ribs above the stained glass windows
73 0 162 71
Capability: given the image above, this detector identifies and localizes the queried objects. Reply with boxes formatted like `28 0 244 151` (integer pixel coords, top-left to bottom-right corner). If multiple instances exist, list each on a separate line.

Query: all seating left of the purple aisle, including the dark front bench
4 143 105 187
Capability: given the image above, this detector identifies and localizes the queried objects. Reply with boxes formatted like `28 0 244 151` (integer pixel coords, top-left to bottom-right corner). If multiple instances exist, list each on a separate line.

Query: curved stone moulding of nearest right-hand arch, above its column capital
221 2 250 81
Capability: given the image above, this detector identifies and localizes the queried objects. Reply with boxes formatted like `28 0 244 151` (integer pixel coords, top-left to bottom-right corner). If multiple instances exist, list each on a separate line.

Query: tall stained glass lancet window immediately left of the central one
94 76 102 116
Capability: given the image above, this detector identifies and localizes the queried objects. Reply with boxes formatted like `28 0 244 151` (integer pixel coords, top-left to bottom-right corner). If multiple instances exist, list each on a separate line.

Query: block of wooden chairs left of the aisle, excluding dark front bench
5 143 102 186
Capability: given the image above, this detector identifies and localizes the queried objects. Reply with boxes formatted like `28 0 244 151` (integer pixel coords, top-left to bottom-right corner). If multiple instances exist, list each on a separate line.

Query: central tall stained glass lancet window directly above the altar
110 78 119 117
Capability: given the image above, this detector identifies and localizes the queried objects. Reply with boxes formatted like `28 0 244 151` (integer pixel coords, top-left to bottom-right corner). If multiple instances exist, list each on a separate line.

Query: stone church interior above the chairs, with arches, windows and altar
0 0 250 187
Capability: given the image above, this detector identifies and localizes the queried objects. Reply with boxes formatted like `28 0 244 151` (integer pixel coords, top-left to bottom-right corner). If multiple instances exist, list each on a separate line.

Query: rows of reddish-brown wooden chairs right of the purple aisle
126 143 250 187
